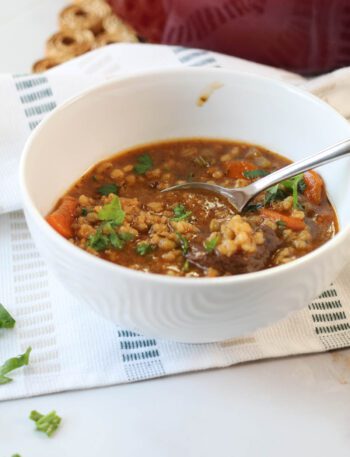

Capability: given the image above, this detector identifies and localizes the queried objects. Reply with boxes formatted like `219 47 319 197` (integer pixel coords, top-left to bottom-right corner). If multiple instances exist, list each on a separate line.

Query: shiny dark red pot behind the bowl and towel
110 0 350 74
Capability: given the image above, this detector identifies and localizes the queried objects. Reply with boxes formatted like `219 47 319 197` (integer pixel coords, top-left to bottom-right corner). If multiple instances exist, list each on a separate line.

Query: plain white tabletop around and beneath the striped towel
0 0 350 457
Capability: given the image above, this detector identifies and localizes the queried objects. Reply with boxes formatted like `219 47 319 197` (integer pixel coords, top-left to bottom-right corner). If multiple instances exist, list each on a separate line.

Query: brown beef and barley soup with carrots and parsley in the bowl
47 139 337 277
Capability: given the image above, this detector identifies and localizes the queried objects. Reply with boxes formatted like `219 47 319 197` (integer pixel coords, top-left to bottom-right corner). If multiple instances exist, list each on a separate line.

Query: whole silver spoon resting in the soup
162 139 350 213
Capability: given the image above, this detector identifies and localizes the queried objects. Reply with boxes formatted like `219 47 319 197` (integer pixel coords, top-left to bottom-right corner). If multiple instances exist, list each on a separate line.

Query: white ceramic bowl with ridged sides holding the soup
21 69 350 342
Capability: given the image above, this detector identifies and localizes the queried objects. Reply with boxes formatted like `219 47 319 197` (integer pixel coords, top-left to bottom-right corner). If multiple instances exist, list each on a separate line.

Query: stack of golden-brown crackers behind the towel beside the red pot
33 0 139 73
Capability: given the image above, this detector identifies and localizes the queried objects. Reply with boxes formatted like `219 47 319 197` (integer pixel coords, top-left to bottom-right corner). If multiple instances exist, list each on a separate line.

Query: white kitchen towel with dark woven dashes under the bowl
0 44 350 399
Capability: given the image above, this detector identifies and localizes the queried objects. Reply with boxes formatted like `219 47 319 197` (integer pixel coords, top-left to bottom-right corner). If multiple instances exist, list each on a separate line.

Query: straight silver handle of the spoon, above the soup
249 139 350 194
